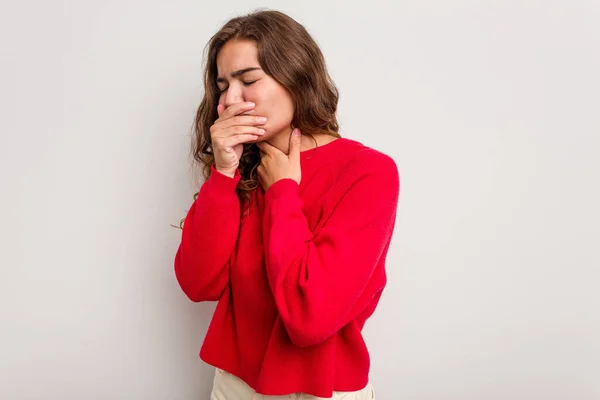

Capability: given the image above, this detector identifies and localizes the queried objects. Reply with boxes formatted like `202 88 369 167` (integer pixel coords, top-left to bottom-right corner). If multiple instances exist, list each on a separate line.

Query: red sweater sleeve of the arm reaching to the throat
263 156 400 346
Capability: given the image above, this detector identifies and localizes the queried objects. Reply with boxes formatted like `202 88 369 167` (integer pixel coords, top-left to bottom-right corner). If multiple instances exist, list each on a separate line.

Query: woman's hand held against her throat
257 129 302 192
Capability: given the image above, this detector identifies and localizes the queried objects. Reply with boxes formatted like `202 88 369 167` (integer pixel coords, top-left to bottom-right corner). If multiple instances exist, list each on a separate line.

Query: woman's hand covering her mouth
210 103 267 178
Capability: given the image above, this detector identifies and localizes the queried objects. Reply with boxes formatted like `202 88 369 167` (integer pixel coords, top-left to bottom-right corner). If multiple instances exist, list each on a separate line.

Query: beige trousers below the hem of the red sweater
210 368 375 400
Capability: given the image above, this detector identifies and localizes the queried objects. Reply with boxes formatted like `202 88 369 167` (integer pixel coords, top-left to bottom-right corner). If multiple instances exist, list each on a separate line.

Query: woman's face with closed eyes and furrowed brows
217 40 294 141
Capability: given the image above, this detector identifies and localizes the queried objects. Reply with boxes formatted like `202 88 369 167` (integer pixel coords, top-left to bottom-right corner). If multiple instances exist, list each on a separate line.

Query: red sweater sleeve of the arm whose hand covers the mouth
175 165 241 301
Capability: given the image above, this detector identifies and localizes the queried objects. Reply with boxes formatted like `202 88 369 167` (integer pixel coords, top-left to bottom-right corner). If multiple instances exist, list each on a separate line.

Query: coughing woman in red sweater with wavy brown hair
175 11 399 400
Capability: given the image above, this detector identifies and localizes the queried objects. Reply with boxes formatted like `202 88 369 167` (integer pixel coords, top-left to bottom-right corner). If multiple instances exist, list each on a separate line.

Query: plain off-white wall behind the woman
0 0 600 400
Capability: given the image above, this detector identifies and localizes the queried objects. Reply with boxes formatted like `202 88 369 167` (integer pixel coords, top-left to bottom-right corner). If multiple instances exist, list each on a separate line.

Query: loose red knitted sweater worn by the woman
175 139 399 397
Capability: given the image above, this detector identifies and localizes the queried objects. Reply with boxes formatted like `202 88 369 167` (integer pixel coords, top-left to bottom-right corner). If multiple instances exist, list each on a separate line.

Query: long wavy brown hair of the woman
192 10 340 209
